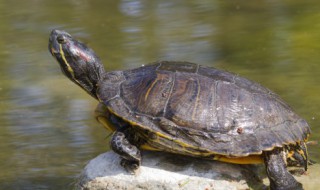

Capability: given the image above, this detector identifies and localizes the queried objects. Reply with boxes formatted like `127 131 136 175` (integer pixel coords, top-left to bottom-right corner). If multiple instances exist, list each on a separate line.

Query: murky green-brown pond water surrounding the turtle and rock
0 0 320 189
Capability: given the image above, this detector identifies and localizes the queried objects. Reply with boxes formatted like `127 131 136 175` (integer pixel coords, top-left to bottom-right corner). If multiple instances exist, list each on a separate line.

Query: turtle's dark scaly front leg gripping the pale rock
111 131 141 174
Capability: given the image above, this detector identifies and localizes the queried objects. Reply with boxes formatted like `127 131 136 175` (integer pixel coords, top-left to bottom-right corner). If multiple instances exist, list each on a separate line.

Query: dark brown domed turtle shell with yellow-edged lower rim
98 62 310 157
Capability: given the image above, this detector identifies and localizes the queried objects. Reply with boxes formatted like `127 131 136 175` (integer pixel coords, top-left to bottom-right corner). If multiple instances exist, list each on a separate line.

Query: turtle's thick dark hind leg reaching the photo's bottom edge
264 148 303 190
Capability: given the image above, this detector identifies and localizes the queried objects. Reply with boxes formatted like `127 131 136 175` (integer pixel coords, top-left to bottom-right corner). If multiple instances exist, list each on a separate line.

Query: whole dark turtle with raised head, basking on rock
48 29 311 189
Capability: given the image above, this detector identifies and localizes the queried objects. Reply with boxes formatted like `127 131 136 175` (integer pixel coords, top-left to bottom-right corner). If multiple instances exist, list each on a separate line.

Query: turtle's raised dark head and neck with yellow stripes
49 30 105 98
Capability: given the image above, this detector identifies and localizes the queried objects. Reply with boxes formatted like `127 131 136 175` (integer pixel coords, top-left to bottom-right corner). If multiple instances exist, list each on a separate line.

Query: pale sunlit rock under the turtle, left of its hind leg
77 151 266 190
